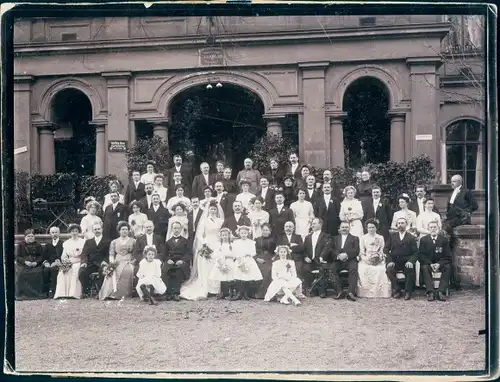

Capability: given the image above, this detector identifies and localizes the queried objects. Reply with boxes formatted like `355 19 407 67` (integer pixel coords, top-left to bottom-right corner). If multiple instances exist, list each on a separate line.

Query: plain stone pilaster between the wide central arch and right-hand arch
299 62 329 167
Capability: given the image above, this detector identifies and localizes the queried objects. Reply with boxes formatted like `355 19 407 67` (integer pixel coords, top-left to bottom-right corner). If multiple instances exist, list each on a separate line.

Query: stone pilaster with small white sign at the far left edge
14 75 33 173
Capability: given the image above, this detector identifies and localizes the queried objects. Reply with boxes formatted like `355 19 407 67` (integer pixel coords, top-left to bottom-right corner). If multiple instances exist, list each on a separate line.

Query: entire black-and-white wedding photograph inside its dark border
12 8 491 374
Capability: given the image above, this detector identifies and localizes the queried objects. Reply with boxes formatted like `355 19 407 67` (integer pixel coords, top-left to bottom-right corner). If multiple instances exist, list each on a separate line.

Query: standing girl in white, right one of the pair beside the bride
232 226 262 300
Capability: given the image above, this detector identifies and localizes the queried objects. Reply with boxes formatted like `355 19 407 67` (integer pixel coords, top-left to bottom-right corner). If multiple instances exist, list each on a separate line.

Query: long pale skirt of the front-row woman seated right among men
358 261 391 298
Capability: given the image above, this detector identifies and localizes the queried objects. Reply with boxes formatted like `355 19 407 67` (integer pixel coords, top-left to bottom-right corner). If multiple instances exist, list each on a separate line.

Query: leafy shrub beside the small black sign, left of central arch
126 135 172 175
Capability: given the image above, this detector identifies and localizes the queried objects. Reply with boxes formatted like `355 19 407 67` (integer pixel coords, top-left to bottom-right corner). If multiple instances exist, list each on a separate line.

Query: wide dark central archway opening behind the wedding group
169 83 267 174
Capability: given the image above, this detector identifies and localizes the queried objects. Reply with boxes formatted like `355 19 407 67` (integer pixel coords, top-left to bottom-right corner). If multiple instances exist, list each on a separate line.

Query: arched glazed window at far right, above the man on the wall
446 119 484 190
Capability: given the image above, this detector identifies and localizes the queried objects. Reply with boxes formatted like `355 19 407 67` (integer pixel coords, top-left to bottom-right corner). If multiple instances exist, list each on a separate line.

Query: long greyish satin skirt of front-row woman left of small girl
99 260 134 300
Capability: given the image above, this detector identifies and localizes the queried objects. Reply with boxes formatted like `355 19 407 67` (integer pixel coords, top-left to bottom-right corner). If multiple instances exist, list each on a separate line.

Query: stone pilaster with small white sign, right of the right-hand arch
406 57 441 166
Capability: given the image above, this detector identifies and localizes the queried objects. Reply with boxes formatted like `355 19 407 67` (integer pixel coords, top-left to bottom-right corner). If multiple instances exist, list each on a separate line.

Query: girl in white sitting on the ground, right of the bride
264 245 302 306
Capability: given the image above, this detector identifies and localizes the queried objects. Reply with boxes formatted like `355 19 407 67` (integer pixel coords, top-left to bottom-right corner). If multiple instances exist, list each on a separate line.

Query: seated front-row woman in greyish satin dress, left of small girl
99 221 135 300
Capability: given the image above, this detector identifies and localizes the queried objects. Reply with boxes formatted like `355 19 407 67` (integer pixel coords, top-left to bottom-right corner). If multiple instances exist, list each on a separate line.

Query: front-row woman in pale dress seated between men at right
358 219 391 298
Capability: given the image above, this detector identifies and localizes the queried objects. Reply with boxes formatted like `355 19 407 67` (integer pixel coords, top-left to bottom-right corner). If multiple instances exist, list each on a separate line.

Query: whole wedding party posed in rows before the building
16 153 478 305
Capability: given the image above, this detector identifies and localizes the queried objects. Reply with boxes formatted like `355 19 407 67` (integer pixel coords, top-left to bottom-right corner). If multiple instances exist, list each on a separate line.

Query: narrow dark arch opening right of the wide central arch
342 77 390 168
